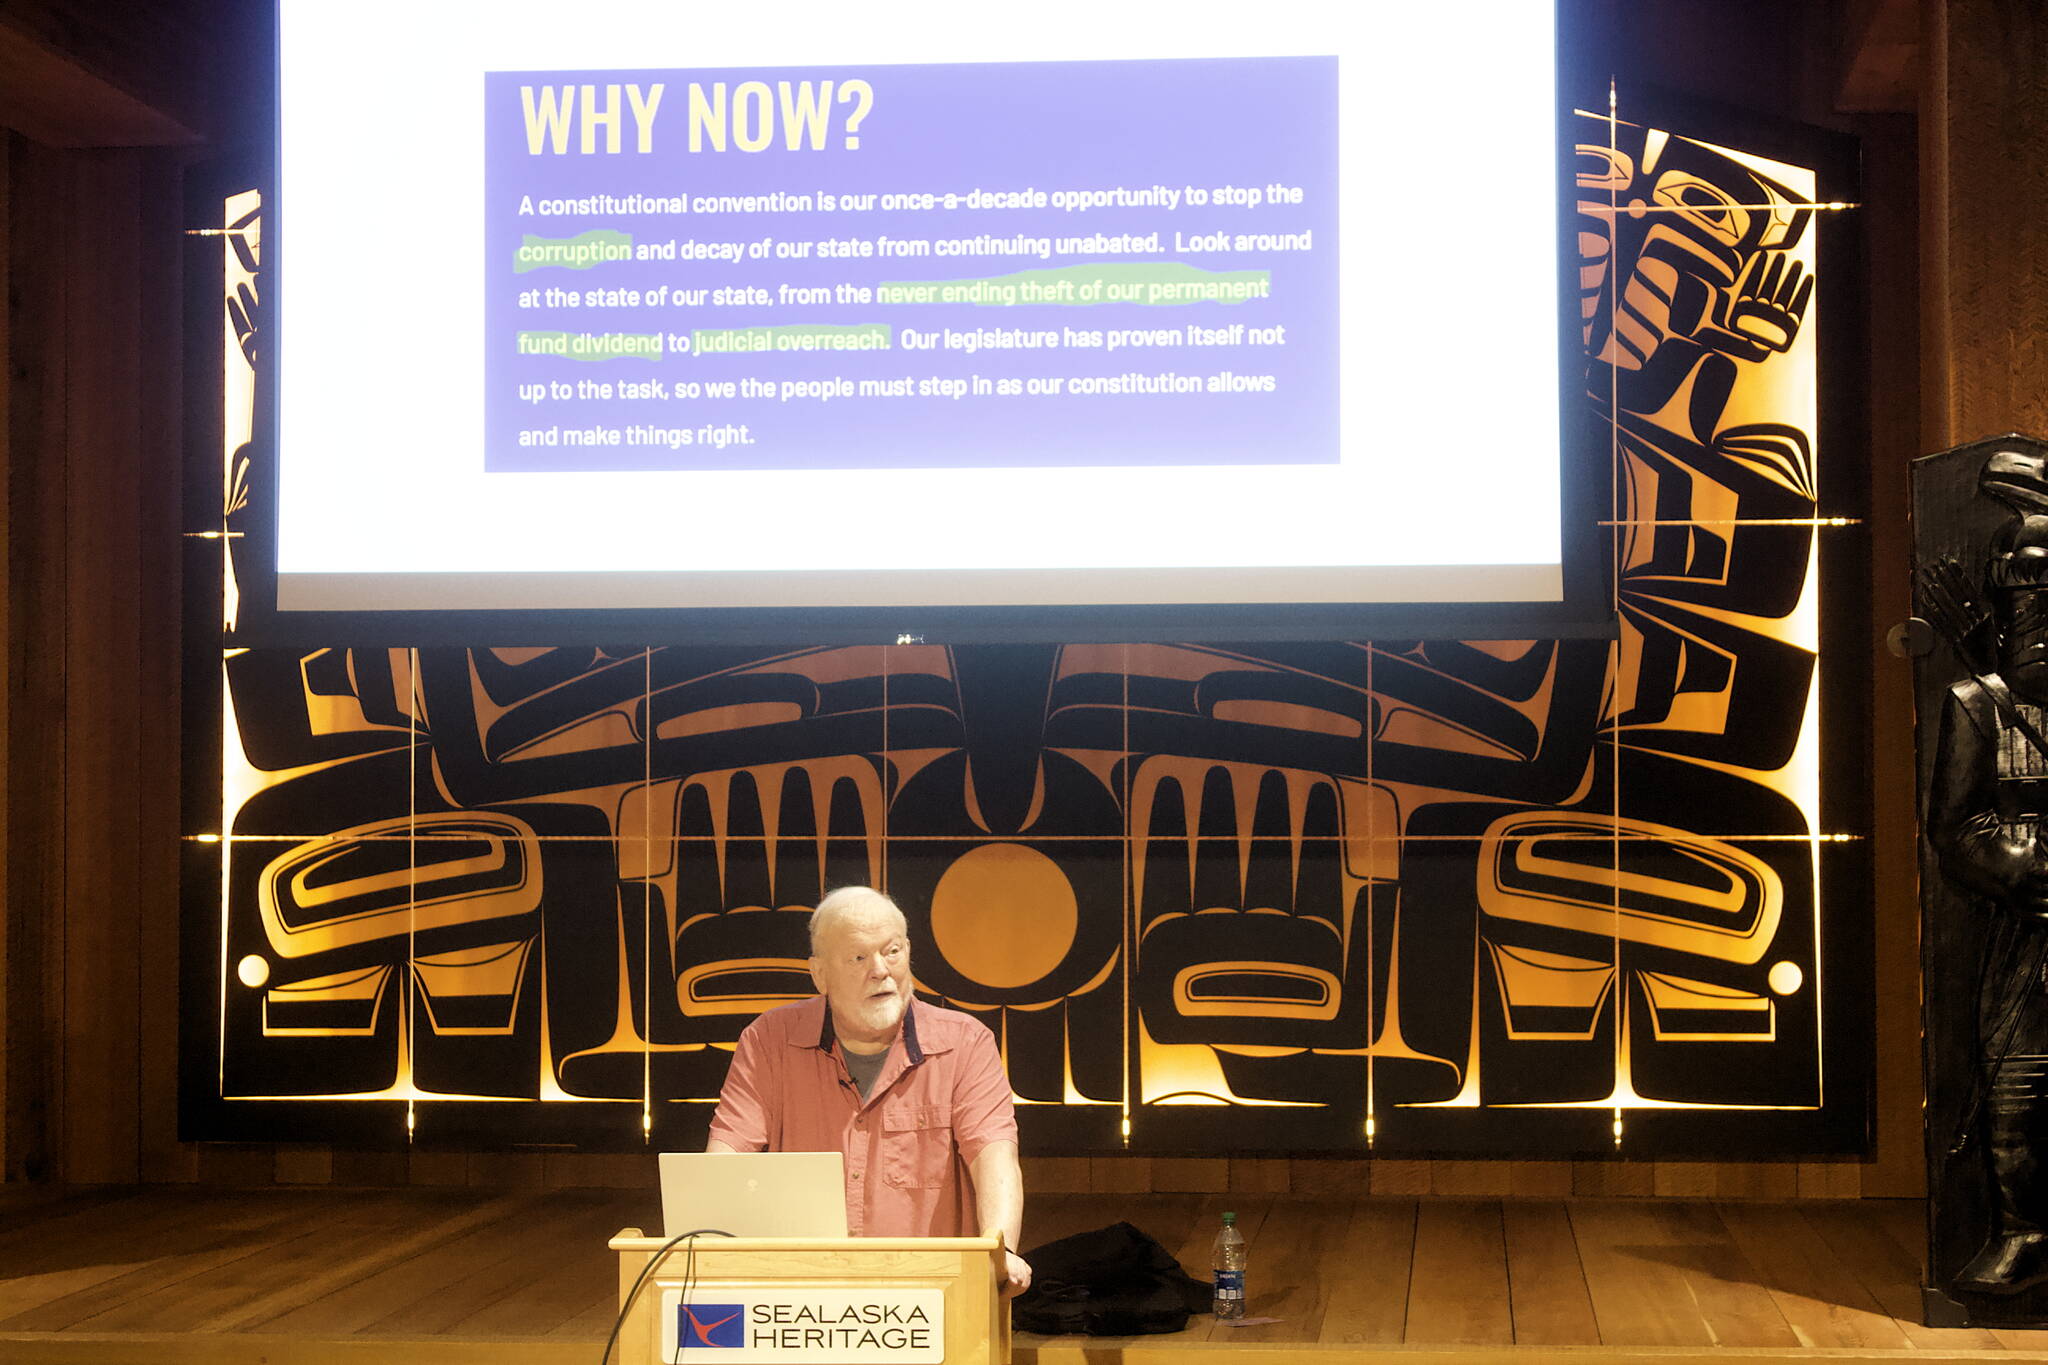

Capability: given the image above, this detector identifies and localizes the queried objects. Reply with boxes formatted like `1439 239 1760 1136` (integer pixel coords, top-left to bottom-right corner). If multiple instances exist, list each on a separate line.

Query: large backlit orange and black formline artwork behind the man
193 119 1859 1152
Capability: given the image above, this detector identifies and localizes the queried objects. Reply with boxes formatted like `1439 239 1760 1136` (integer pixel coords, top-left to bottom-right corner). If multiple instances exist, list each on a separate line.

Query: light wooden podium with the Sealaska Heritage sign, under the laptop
610 1228 1010 1365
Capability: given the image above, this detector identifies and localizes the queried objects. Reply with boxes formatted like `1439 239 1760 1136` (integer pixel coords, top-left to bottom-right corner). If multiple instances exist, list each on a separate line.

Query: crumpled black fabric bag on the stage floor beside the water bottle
1010 1224 1212 1336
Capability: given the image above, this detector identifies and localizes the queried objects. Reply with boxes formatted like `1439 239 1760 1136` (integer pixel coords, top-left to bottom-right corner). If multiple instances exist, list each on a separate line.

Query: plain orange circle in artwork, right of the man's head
932 843 1081 990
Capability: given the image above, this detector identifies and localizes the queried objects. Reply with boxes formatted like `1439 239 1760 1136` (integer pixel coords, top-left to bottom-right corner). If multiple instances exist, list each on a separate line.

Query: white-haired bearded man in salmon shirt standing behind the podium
705 886 1030 1293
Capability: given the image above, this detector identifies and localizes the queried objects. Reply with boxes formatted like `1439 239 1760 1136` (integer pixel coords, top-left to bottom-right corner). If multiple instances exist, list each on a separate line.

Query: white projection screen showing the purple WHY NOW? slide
270 0 1563 610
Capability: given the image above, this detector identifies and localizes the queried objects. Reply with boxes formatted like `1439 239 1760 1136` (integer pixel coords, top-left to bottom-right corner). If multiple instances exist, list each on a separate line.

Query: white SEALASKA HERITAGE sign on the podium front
662 1283 946 1365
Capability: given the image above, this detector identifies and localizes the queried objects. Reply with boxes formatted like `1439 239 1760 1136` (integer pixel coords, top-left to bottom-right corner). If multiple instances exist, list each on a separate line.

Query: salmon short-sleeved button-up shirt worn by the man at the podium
711 995 1018 1236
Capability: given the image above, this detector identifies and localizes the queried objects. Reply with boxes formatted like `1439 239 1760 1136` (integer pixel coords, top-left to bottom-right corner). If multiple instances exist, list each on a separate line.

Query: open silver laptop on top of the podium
659 1152 846 1238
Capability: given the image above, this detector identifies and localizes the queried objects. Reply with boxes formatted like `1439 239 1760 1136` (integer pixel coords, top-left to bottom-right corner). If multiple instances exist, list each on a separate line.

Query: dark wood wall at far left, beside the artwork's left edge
6 141 182 1181
